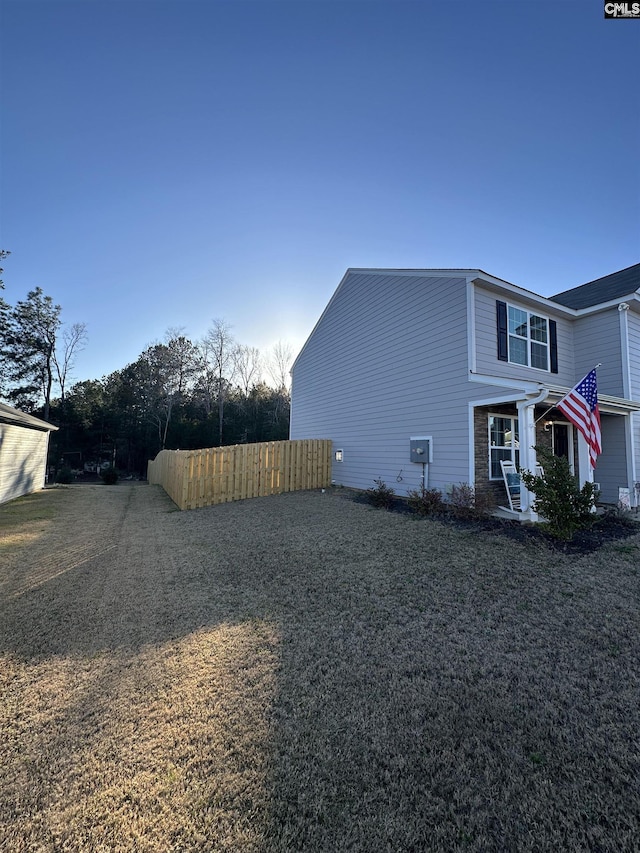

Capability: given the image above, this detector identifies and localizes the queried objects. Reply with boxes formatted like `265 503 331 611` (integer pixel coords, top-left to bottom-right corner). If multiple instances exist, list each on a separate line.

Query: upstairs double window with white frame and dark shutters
496 301 558 373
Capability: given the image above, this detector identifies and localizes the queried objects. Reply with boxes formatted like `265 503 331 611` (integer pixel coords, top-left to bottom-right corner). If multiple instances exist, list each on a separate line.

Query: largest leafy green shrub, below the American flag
520 447 597 541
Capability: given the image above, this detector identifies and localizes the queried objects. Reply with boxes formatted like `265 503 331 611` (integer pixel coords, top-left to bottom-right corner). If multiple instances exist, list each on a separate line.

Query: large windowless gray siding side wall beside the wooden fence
291 272 478 494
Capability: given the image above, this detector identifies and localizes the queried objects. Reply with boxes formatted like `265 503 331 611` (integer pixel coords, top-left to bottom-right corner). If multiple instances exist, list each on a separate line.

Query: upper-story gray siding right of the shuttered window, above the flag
570 308 625 397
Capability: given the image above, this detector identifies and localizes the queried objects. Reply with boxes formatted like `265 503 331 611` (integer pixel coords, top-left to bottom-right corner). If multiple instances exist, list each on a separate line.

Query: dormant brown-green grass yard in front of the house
0 483 640 853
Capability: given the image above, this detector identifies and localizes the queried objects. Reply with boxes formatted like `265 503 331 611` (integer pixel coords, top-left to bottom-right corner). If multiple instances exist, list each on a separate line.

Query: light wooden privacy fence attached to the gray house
147 439 331 509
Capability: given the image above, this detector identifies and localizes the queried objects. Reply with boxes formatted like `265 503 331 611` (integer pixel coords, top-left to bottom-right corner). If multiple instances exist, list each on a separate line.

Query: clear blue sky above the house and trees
0 0 640 379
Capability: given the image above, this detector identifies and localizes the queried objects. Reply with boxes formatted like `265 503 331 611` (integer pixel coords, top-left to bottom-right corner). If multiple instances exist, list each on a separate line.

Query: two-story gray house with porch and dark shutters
291 264 640 519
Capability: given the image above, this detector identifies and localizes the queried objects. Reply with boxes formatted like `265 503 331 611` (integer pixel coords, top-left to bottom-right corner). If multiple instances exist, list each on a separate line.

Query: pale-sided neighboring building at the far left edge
0 403 58 504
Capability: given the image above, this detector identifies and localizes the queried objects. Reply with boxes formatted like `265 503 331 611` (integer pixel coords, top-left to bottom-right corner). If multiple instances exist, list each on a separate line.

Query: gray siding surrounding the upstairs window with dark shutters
474 285 575 385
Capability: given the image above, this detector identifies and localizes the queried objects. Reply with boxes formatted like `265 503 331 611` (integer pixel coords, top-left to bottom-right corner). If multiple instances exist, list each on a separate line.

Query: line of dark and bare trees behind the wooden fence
0 264 293 476
